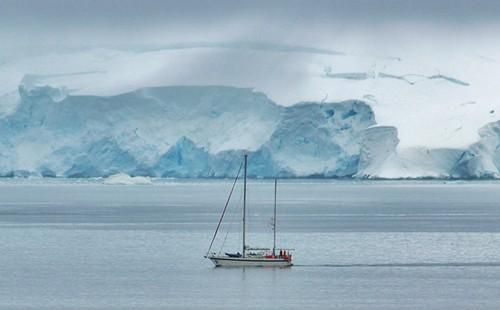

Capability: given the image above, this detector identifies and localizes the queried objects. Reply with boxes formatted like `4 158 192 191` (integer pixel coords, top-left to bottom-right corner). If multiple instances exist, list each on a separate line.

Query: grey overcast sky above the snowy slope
0 0 500 54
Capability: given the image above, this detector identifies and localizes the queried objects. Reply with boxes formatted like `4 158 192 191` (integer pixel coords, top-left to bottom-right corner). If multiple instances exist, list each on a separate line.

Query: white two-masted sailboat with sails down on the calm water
205 154 293 267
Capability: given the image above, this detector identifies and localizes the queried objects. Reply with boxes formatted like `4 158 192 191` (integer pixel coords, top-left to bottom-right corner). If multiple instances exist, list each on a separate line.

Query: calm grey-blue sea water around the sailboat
0 180 500 309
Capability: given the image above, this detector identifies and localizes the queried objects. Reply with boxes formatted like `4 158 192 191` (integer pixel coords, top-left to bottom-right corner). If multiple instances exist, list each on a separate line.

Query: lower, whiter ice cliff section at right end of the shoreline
357 121 500 179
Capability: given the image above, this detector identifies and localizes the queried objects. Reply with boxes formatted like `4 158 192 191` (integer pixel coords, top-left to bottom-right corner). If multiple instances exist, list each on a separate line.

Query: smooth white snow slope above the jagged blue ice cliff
0 46 500 154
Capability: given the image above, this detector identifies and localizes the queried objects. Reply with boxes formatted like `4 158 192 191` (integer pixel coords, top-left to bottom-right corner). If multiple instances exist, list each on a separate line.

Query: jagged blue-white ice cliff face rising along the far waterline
0 83 500 179
